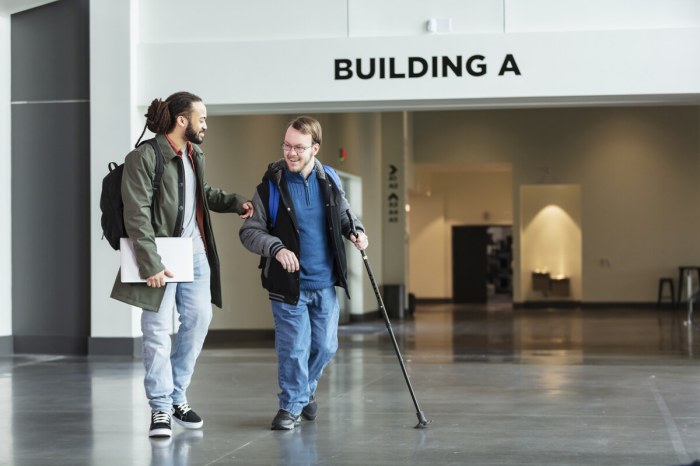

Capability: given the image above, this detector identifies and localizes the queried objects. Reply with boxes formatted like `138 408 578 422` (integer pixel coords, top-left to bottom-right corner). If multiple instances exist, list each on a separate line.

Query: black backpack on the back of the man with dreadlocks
100 139 164 250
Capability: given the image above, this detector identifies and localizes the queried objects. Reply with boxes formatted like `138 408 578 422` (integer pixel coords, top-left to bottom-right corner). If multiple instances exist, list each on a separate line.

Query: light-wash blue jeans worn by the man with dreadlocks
141 253 212 413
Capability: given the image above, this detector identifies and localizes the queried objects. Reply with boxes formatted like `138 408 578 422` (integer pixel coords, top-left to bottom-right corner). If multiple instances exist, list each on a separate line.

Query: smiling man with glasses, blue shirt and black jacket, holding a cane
240 116 368 430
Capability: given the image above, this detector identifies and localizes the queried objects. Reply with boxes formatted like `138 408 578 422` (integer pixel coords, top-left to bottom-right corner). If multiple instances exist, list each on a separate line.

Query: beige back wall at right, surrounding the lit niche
414 106 700 302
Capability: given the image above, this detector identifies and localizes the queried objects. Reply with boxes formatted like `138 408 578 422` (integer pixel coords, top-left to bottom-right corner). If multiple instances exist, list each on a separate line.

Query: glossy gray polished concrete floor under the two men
0 303 700 466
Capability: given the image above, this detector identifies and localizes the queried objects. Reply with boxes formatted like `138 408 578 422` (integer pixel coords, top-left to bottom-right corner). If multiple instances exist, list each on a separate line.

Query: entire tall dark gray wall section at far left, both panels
10 0 90 354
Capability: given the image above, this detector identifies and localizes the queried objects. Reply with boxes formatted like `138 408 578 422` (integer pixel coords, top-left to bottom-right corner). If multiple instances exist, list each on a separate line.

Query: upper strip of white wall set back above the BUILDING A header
135 0 700 43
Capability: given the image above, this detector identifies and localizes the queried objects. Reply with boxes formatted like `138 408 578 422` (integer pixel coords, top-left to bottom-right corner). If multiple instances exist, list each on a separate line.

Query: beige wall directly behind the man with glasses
202 114 382 329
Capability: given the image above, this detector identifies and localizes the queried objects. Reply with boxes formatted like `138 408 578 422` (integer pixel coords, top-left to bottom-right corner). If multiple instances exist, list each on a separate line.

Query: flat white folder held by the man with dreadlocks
119 238 194 283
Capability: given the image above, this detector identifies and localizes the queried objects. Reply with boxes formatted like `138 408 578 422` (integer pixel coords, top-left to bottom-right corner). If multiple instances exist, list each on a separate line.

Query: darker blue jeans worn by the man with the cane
270 286 340 415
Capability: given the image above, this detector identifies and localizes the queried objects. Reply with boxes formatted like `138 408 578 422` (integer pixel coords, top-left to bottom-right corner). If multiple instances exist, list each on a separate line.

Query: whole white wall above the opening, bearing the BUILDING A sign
131 0 700 114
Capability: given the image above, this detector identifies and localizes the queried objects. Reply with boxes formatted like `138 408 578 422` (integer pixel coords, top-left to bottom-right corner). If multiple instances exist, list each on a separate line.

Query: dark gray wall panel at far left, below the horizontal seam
12 103 90 346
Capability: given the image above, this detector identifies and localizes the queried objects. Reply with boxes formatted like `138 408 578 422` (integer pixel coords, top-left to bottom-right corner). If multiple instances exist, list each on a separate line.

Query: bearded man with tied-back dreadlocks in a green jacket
111 92 253 437
